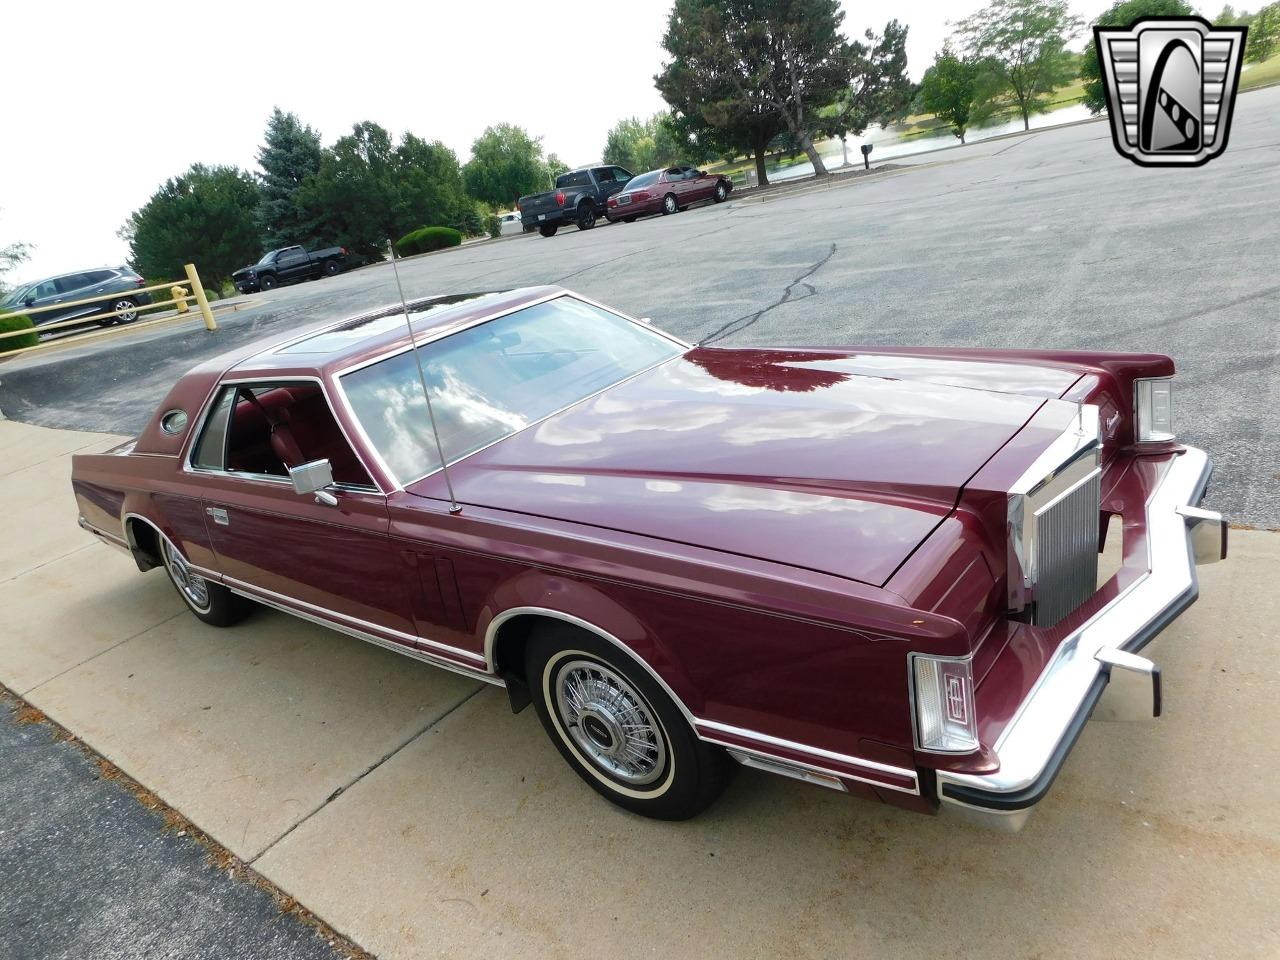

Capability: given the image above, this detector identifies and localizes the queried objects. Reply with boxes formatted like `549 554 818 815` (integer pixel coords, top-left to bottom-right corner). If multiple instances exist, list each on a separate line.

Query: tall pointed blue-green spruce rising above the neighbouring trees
257 108 324 247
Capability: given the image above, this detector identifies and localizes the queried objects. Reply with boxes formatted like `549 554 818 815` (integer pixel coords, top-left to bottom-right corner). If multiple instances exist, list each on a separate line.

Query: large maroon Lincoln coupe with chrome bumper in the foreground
73 288 1226 828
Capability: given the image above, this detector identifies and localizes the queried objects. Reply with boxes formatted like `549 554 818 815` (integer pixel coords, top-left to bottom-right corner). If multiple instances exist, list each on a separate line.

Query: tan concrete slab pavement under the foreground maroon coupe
0 422 1280 960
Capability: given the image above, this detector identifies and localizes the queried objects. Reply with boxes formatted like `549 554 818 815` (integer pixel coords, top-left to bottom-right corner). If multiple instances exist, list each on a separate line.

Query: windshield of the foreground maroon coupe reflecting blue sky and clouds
342 297 684 485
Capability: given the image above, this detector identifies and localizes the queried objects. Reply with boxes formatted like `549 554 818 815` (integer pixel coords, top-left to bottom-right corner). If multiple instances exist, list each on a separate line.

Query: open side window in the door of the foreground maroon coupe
192 383 375 489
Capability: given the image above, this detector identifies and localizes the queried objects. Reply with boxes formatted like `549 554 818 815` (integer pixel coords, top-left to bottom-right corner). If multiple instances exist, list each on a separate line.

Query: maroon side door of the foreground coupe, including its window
188 380 415 645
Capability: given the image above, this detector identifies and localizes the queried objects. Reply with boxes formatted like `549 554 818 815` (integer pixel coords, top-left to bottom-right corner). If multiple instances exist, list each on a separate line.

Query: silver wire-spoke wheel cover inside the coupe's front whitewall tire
556 659 667 786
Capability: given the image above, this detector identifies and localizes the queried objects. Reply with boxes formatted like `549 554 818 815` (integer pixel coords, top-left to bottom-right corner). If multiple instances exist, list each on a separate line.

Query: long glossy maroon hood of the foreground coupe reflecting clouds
408 348 1074 586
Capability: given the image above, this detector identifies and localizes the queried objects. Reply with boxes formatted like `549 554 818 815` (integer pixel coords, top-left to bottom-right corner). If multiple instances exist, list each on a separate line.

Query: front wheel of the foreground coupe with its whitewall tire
525 625 735 820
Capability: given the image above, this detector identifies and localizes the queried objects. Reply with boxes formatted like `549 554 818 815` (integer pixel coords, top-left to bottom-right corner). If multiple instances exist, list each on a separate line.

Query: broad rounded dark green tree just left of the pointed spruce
123 164 261 284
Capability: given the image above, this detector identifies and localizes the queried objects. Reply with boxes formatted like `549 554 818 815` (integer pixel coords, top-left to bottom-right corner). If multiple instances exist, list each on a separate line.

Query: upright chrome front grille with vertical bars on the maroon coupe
1033 470 1102 626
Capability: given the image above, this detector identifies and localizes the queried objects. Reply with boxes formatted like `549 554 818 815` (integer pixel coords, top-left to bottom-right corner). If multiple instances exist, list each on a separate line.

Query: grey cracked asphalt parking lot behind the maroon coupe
0 87 1280 529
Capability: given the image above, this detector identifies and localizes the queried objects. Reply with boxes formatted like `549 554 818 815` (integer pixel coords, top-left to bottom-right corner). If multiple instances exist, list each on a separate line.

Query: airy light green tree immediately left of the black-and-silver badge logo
956 0 1083 129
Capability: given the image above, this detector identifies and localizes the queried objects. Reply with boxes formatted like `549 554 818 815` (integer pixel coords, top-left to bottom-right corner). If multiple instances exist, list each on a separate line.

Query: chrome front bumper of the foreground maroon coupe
937 448 1226 831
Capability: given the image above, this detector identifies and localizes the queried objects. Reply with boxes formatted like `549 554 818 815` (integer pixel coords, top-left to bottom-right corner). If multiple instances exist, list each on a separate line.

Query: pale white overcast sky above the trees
0 0 1110 282
